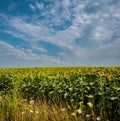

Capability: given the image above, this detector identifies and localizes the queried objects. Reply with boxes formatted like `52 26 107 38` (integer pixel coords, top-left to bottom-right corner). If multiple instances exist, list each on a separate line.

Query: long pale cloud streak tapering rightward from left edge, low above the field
0 41 62 64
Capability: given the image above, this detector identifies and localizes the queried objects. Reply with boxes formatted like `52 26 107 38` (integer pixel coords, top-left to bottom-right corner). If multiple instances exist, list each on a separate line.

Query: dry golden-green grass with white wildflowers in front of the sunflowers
0 96 83 121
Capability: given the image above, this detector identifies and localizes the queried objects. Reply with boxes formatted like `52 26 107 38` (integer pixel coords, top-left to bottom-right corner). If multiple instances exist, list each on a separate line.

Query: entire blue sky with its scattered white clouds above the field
0 0 120 67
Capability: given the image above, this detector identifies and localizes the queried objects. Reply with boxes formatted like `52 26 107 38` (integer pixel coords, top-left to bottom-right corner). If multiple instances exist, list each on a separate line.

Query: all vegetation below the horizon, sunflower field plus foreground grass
0 67 120 121
